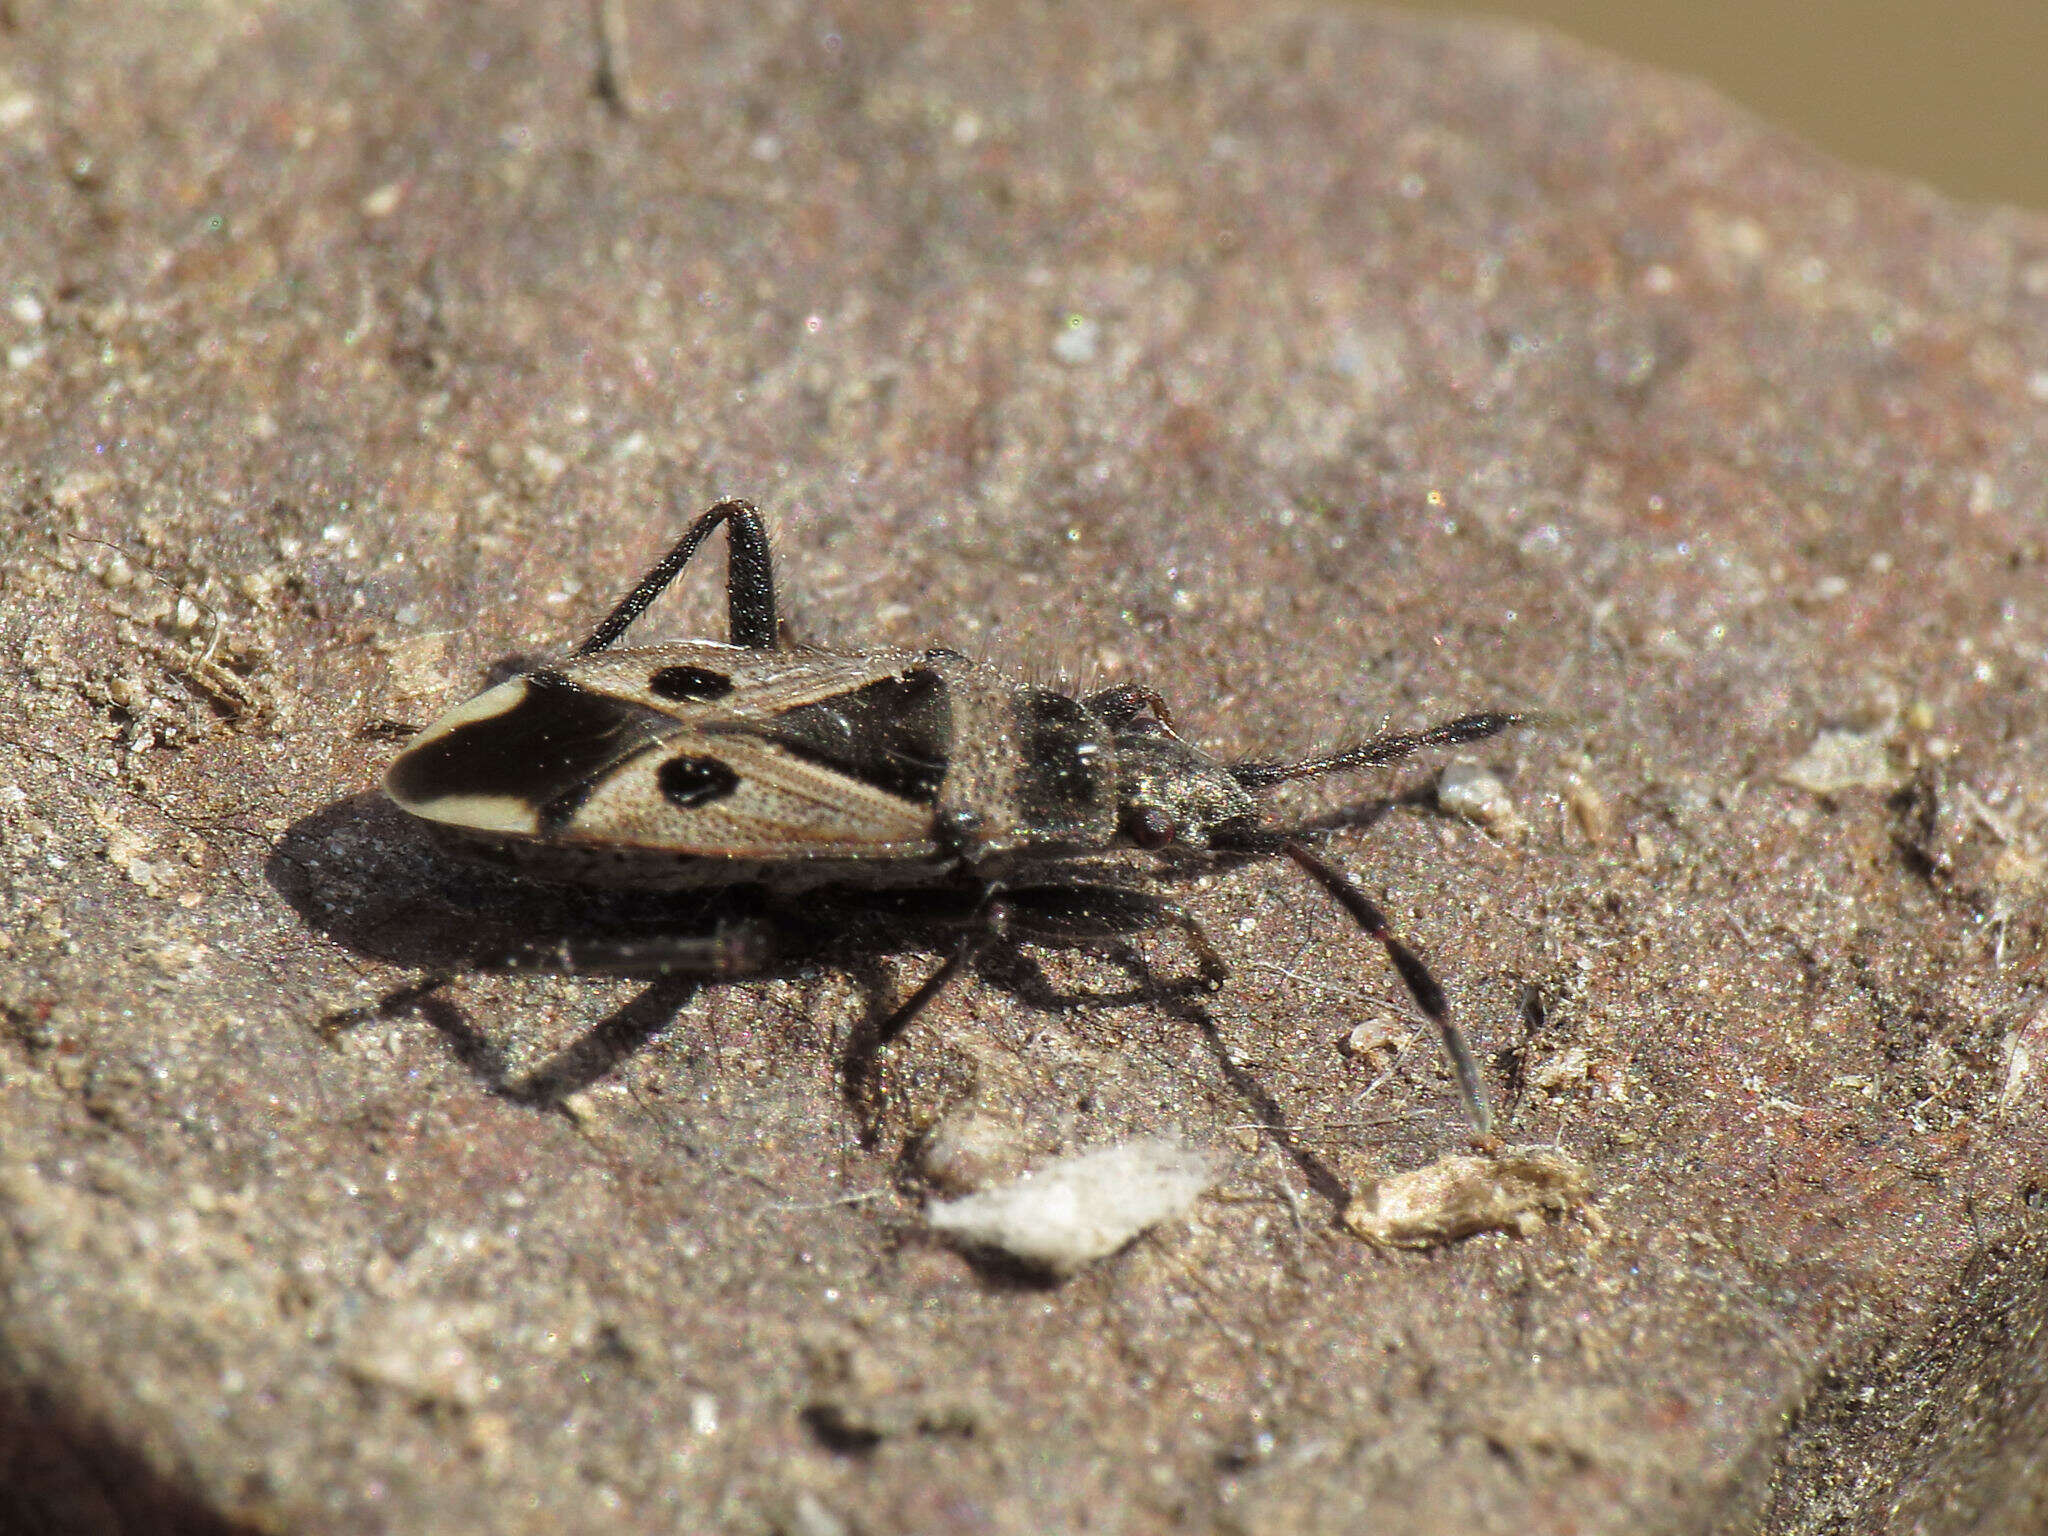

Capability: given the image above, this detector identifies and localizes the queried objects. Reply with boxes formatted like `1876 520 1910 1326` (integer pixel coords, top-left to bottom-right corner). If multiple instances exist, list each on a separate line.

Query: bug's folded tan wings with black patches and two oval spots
385 643 952 860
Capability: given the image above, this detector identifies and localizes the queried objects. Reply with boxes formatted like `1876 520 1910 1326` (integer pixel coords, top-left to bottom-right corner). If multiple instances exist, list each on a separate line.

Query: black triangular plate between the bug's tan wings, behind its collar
762 668 952 805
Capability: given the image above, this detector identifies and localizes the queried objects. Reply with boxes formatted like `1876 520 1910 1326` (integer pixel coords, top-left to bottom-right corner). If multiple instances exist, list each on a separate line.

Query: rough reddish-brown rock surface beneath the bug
0 0 2048 1536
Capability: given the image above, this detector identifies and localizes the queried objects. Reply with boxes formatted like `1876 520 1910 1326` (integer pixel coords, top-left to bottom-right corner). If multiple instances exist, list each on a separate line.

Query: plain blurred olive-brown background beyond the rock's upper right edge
1411 0 2048 209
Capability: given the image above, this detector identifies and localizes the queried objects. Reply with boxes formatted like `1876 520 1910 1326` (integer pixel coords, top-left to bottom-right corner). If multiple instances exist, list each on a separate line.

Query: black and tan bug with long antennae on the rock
385 500 1528 1135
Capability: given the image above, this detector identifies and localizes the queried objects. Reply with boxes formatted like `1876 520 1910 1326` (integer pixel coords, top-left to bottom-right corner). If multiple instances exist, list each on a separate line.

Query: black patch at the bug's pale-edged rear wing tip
389 672 674 825
